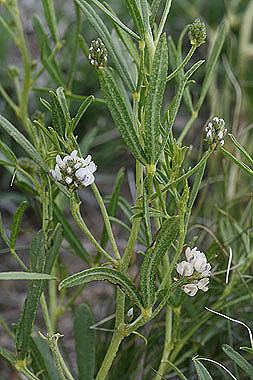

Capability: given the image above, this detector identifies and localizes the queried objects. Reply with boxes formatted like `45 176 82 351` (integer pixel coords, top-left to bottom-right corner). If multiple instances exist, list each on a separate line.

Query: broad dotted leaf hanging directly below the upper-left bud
98 68 145 164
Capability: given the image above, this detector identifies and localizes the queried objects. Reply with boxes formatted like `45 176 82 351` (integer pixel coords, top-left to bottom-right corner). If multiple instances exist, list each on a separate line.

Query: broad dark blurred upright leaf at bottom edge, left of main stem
74 304 96 380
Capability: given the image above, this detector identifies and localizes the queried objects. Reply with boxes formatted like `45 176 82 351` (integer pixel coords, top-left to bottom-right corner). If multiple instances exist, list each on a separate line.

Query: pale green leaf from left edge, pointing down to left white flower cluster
0 115 48 171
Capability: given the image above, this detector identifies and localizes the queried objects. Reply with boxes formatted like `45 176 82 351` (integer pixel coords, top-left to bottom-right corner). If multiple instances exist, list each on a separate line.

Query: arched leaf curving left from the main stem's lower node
59 267 142 308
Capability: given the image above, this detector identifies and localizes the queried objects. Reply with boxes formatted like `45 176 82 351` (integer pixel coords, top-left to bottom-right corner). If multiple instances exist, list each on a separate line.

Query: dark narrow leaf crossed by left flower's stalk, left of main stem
100 169 125 248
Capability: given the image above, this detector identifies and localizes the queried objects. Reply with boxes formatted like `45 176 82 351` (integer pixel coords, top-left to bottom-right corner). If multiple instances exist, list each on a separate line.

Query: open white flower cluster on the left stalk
50 150 97 189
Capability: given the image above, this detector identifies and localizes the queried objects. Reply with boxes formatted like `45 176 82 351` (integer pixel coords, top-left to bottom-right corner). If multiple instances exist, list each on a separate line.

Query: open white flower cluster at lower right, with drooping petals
177 247 211 297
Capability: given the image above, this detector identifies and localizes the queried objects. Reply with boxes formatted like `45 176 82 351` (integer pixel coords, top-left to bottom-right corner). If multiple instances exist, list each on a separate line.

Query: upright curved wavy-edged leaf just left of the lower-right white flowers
141 216 179 307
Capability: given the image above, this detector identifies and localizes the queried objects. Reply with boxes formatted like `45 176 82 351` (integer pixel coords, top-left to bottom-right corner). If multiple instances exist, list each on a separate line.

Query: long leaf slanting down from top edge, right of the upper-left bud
76 0 135 91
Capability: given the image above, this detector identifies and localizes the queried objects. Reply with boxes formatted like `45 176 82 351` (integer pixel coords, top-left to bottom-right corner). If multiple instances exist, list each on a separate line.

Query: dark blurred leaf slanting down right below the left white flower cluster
53 204 91 264
